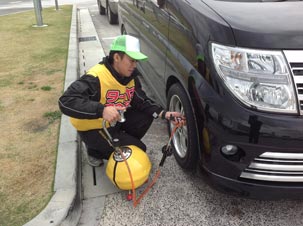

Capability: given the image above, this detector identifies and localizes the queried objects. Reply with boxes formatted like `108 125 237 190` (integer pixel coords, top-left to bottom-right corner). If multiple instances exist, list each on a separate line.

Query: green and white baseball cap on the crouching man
110 35 148 60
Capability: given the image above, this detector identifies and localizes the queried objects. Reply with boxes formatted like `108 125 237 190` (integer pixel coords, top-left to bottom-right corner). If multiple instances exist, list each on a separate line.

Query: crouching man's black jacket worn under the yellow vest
59 57 163 119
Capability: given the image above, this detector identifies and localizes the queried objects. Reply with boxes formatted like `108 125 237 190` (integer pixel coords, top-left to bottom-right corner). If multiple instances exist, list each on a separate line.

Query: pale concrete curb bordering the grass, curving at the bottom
24 4 81 226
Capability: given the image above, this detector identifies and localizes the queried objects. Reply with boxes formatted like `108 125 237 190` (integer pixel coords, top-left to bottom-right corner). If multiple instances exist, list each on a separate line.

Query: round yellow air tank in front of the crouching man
106 145 151 190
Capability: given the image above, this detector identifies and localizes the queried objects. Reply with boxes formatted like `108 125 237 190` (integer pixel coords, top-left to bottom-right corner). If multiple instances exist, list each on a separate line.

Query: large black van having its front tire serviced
118 0 303 199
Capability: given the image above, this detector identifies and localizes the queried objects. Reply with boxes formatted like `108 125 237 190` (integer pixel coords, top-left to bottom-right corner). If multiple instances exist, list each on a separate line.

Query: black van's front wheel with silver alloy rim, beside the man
167 83 198 171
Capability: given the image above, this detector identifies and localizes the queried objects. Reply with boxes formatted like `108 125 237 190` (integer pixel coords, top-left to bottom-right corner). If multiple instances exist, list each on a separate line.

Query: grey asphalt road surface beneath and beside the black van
78 1 303 226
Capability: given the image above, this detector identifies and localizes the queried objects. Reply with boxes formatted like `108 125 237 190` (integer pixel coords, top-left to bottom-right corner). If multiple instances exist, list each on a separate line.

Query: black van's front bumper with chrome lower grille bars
202 92 303 199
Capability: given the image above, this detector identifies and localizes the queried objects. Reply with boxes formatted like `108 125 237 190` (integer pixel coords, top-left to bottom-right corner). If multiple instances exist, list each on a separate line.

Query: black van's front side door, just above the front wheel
164 0 198 90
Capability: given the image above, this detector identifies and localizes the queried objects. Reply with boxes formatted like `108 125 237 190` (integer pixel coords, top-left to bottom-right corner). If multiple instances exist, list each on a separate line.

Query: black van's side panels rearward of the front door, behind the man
120 0 169 106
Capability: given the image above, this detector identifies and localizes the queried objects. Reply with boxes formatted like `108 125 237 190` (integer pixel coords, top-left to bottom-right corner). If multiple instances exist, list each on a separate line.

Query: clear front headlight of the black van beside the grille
211 43 296 113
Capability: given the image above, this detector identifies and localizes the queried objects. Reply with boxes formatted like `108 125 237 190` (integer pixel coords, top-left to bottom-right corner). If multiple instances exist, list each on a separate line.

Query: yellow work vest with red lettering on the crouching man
70 64 135 131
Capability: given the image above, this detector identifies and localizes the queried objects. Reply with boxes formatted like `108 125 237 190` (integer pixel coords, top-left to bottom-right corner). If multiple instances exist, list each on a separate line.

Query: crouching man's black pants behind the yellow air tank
78 108 153 159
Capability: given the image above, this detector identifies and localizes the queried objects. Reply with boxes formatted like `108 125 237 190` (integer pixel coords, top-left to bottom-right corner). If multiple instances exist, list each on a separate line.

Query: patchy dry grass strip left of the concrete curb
0 6 72 226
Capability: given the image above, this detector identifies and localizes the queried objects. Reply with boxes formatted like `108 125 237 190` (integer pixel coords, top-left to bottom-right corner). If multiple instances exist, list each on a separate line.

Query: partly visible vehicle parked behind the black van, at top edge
97 0 119 24
